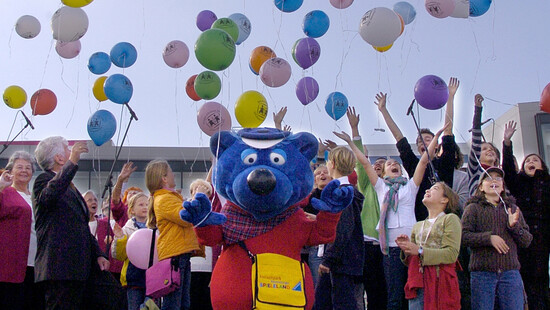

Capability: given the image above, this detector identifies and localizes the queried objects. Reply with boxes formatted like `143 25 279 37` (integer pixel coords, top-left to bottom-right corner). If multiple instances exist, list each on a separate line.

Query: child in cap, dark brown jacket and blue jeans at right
462 167 533 310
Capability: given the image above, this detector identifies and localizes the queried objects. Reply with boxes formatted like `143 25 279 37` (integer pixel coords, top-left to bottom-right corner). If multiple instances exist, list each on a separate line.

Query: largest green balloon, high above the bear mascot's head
195 29 235 71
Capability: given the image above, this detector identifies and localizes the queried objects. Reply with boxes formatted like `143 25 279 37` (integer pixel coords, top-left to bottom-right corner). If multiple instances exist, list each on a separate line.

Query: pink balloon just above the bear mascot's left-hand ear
197 101 231 136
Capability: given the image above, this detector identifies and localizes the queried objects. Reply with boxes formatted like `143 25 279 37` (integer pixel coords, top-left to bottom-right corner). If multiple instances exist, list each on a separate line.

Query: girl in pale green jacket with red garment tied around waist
397 182 462 310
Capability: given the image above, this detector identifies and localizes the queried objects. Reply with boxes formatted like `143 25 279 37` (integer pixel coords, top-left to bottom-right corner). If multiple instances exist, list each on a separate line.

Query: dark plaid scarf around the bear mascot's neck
221 201 299 245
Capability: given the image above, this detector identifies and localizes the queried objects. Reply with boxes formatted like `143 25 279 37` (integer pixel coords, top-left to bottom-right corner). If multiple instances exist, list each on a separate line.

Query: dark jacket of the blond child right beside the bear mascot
323 187 365 276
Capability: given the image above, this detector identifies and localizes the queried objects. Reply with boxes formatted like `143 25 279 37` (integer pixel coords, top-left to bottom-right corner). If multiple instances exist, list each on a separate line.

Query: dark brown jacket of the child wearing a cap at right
462 196 533 272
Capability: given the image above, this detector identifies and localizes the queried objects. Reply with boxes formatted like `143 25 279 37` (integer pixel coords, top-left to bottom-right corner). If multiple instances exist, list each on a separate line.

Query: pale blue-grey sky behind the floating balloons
0 0 550 153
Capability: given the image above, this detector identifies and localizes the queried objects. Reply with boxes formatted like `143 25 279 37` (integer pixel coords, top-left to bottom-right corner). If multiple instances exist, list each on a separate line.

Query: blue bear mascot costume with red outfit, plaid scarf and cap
180 128 353 310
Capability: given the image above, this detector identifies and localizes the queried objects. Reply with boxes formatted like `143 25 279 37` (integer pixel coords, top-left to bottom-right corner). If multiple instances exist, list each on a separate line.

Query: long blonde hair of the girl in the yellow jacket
145 159 170 228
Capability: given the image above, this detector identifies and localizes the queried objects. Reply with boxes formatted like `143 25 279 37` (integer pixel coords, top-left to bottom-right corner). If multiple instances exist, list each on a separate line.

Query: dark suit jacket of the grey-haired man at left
33 161 105 282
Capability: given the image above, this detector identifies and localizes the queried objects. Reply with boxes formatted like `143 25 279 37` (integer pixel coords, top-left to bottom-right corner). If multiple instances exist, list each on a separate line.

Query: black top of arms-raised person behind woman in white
396 135 456 221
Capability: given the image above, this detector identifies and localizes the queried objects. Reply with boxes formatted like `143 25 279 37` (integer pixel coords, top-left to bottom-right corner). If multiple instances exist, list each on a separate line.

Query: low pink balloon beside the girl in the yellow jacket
126 228 159 269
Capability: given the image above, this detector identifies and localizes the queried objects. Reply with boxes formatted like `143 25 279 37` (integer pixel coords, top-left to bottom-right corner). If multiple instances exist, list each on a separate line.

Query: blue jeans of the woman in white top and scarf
383 247 407 310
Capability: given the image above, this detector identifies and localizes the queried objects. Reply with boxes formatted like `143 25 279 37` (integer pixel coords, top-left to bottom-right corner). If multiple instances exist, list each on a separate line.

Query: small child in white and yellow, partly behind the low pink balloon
111 193 148 310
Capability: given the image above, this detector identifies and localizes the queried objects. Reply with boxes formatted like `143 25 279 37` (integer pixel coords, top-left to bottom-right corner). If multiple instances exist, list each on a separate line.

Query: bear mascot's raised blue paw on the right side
311 180 353 213
